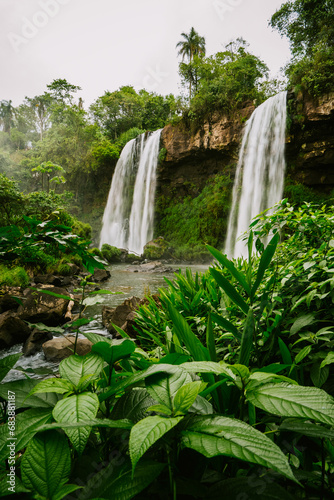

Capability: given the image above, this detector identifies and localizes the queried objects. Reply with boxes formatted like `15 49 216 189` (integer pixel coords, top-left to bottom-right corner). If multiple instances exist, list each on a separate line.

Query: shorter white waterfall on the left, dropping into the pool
100 130 161 254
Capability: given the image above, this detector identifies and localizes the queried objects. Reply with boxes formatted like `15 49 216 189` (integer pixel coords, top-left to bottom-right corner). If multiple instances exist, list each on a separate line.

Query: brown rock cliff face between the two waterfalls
158 103 254 197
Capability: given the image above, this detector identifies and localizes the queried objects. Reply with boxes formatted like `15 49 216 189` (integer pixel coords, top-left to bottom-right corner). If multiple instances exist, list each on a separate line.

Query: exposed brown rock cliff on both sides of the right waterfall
158 93 334 198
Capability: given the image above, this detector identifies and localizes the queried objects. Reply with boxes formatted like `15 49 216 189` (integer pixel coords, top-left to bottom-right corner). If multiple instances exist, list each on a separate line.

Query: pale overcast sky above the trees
0 0 290 108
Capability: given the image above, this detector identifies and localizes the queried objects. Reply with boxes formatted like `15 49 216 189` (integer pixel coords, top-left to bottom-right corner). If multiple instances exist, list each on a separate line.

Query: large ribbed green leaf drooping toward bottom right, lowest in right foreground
181 415 296 481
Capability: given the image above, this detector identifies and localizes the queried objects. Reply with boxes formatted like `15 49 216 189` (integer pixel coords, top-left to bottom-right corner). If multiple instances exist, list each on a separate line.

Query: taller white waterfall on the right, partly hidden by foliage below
225 92 286 258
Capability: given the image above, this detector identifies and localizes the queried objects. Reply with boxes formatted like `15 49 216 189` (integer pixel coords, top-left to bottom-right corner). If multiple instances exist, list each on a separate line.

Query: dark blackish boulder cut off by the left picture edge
0 311 31 349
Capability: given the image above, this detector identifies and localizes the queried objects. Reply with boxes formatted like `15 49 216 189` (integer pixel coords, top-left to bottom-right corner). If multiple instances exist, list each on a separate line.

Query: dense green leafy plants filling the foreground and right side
0 200 334 500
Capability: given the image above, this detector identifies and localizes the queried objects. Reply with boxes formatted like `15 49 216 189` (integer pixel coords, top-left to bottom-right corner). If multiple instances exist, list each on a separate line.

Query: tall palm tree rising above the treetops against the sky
176 28 205 99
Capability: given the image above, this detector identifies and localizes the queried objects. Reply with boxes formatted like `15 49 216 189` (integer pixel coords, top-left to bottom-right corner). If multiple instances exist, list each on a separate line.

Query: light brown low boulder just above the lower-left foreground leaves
42 335 93 361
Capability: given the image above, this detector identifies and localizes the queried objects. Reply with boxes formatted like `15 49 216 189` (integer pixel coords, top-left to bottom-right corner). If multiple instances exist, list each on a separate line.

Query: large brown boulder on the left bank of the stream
17 286 70 326
